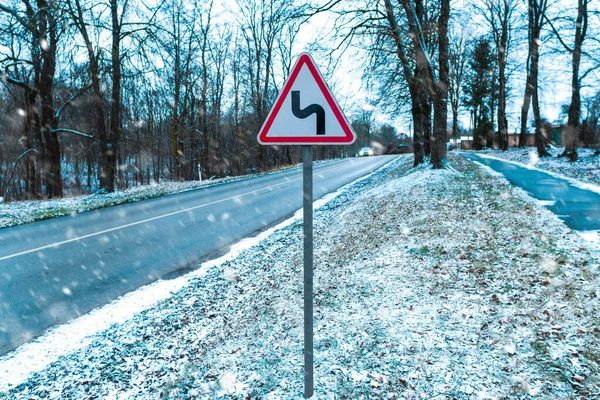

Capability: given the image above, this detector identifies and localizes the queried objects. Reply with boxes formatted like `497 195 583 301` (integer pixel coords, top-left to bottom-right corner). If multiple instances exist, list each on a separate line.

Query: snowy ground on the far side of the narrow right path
476 147 600 189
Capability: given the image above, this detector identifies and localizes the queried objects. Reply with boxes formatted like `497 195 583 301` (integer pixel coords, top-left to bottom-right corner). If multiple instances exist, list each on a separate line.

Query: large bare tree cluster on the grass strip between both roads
348 0 450 167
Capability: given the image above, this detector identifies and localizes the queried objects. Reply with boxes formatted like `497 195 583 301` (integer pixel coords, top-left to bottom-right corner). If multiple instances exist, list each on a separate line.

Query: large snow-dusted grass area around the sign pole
0 157 600 399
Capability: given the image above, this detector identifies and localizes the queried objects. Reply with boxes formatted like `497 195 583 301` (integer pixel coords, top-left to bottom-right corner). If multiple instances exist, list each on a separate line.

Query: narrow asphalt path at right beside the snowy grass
460 153 600 231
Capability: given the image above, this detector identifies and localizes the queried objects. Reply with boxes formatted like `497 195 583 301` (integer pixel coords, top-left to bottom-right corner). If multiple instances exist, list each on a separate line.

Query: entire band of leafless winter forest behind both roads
0 0 600 200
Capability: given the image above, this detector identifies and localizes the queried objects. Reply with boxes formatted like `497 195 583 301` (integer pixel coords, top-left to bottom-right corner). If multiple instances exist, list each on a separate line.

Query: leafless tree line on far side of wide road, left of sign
0 0 400 199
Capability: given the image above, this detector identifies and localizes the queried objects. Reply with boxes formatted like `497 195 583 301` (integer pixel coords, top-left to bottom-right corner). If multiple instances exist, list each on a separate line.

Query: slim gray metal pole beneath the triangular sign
302 145 314 398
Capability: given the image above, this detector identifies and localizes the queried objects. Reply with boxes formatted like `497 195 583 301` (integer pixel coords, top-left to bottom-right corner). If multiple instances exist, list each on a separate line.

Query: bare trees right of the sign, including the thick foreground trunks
332 0 600 162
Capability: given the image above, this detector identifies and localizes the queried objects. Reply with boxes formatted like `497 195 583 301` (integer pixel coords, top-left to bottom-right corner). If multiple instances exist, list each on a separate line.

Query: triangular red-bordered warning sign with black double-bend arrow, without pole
258 53 356 144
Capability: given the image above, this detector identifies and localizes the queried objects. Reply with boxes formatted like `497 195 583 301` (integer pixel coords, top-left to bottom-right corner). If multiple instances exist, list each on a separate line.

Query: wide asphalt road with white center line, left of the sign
0 156 397 355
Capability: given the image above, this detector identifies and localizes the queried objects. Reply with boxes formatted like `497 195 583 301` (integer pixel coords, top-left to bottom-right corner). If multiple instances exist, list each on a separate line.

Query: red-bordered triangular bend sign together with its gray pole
258 53 356 398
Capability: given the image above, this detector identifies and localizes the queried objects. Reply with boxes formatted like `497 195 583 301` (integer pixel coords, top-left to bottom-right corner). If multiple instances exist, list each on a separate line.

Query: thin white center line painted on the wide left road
0 158 384 261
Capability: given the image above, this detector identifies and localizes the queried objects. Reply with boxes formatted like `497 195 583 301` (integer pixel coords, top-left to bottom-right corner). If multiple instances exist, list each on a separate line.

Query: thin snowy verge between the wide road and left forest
0 166 310 228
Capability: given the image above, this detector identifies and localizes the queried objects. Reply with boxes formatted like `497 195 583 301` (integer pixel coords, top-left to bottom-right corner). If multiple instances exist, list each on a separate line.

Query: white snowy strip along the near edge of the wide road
0 157 401 393
